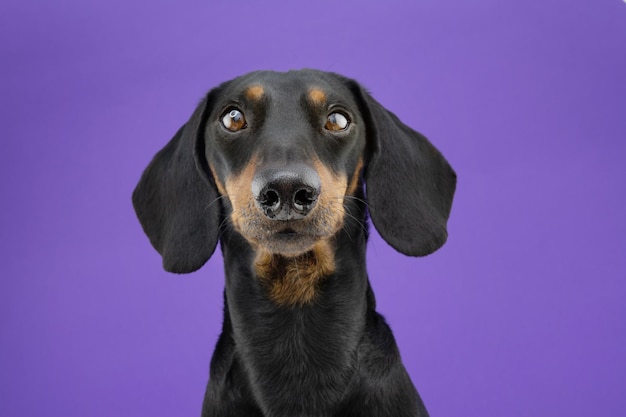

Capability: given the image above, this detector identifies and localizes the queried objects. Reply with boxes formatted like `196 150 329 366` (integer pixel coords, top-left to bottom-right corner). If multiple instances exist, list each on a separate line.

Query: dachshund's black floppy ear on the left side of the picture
133 97 220 273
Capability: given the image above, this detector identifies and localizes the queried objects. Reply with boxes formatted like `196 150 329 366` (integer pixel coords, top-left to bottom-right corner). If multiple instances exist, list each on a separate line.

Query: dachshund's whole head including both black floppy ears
133 70 456 272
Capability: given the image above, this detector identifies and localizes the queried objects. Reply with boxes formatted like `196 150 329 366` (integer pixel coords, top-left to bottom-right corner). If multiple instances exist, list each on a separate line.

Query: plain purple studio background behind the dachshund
0 0 626 417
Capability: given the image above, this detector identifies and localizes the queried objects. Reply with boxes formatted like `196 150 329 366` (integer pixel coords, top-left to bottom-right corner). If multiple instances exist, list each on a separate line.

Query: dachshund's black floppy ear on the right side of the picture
359 88 456 256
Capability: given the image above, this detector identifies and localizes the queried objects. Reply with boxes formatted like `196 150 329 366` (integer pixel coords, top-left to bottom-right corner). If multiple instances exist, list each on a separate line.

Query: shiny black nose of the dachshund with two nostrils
252 167 321 220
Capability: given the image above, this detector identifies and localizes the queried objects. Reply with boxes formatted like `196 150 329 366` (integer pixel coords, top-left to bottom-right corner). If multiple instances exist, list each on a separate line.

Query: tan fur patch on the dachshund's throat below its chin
254 241 335 307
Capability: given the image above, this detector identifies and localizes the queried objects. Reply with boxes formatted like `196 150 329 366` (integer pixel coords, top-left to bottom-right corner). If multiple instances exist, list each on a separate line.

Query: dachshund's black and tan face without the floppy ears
203 72 366 256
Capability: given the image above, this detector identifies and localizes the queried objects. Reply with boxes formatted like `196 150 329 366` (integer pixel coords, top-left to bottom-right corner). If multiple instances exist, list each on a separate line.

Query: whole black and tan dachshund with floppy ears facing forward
133 70 456 417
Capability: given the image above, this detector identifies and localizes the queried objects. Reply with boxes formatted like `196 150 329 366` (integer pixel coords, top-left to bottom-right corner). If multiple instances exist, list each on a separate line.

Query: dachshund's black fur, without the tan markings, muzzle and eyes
133 70 456 417
